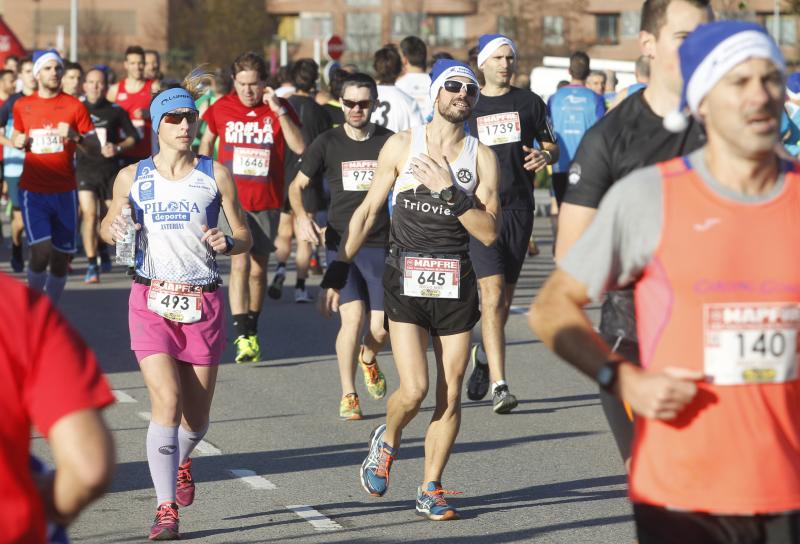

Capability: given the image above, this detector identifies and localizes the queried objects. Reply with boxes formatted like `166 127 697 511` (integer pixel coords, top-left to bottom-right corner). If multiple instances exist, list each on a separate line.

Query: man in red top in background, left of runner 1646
106 45 161 164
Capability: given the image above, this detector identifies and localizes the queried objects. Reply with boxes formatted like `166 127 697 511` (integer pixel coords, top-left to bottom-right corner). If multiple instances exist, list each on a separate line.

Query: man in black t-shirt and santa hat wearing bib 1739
467 34 559 414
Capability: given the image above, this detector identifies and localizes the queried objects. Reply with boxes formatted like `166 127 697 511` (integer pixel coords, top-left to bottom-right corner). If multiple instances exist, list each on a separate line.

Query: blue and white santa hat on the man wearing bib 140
664 21 786 132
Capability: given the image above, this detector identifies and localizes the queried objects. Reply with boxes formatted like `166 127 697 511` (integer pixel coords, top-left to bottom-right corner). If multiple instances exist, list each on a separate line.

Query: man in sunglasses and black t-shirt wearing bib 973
289 74 394 420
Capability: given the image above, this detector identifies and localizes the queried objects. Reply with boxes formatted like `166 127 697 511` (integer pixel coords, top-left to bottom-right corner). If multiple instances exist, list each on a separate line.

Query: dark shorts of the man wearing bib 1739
469 210 533 283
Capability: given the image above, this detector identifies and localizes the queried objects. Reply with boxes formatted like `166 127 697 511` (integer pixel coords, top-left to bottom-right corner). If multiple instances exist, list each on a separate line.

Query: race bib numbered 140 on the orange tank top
703 302 800 385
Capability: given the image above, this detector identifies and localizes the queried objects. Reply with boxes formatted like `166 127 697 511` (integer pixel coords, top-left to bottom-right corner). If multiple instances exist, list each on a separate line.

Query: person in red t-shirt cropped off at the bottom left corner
0 274 114 544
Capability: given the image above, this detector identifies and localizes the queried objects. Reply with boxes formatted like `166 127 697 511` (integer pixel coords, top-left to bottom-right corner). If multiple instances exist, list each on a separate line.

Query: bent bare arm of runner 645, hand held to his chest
458 144 500 246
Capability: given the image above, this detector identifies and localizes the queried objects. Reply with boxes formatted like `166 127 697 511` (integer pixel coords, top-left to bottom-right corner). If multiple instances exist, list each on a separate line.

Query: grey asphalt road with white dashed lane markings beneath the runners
15 215 634 544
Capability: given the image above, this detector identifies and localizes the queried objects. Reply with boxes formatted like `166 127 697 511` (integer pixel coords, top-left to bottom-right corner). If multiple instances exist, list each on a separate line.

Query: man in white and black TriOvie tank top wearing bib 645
322 60 500 521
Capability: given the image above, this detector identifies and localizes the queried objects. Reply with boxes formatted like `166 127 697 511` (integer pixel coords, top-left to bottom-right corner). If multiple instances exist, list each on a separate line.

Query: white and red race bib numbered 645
403 257 461 298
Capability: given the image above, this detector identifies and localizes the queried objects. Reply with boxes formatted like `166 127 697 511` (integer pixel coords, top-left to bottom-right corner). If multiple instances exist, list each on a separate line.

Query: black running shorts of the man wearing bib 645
383 257 481 336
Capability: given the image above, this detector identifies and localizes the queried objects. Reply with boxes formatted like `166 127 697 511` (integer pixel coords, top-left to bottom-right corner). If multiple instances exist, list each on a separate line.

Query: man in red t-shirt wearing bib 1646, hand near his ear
200 52 305 363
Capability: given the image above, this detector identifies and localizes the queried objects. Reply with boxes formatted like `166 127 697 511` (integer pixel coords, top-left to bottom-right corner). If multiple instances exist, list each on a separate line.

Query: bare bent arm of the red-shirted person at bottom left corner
42 409 115 525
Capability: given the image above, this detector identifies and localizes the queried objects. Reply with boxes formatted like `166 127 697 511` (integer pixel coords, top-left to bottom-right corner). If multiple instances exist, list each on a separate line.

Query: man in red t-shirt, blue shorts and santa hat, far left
11 50 97 303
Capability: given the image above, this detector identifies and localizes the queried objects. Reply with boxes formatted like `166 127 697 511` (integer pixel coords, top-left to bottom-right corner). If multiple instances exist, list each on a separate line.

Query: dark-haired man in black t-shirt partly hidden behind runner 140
555 0 712 468
